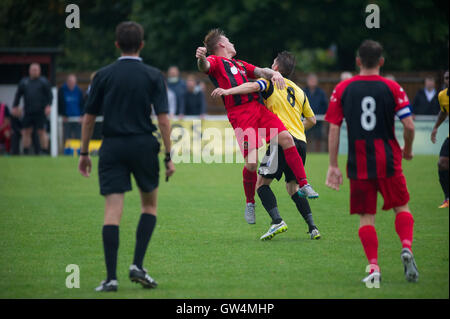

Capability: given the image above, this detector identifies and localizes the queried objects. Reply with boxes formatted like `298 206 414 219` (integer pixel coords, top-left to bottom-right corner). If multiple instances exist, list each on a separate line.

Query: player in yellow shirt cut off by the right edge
431 71 449 208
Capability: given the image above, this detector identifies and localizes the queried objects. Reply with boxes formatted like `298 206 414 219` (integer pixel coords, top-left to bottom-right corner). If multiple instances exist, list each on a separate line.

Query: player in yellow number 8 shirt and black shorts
211 51 320 240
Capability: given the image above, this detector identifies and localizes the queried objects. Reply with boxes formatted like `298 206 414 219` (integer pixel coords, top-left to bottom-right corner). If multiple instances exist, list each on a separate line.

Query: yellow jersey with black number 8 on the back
257 78 314 143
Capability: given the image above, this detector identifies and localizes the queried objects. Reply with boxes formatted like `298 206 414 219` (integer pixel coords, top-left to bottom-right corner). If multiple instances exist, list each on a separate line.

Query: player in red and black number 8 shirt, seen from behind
325 40 419 283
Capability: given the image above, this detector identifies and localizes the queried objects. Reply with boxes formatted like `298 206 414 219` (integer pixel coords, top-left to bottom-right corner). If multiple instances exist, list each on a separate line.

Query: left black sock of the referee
102 225 119 281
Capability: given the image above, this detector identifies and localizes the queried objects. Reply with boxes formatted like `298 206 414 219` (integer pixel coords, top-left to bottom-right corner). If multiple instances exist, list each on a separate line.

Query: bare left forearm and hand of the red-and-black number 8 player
325 123 343 191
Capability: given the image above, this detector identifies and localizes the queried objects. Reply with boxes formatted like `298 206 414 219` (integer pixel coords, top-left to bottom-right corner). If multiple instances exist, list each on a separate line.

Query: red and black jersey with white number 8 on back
325 75 411 179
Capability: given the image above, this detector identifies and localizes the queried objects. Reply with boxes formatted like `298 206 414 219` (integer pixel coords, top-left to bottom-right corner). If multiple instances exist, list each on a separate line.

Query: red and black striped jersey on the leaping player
207 55 262 111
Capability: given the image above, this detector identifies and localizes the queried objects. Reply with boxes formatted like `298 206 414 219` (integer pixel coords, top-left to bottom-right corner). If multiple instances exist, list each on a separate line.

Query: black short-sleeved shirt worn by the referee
85 57 169 137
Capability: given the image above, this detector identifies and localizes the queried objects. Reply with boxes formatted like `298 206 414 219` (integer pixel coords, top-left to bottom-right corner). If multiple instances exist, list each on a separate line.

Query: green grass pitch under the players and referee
0 154 449 298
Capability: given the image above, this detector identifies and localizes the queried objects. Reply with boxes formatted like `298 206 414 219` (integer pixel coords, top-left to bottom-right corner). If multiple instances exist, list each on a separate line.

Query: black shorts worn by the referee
98 135 160 195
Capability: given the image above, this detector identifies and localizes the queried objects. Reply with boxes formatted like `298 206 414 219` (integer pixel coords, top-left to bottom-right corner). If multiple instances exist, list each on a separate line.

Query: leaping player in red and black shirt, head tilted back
196 29 318 224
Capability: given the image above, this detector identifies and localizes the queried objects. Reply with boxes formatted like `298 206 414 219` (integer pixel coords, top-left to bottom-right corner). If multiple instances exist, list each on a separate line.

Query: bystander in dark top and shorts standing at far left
11 63 53 154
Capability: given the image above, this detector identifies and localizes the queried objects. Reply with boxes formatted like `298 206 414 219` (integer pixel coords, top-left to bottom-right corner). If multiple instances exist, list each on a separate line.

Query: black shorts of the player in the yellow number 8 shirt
258 138 306 183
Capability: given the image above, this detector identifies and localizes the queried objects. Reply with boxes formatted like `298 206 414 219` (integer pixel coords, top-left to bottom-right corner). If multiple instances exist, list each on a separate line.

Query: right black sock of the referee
133 213 156 269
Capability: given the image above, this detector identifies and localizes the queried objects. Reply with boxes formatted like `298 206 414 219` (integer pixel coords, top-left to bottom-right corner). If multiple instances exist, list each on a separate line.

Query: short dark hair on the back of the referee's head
116 21 144 53
